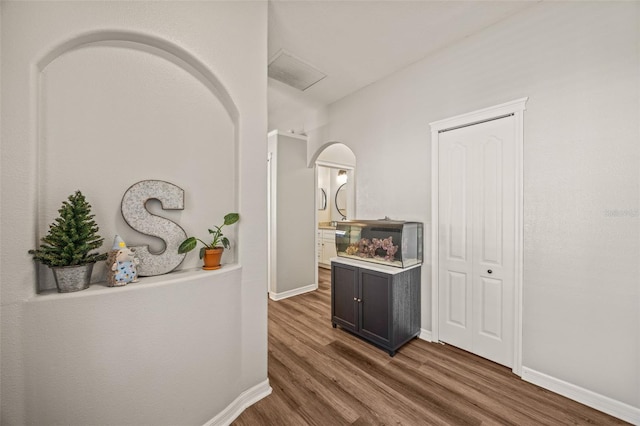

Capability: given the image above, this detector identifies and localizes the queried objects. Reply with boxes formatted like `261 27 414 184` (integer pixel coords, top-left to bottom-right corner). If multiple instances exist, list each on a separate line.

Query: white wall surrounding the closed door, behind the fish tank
322 2 640 422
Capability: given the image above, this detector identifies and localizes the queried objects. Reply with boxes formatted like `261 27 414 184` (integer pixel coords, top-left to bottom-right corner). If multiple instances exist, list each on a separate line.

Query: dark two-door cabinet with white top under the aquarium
331 260 421 356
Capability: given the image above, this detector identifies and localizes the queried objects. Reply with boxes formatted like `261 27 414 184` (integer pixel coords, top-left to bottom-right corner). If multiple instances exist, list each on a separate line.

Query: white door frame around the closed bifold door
429 97 529 376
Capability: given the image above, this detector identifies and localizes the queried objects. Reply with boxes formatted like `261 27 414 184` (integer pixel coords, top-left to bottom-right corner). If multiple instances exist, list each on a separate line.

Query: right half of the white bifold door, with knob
472 117 516 367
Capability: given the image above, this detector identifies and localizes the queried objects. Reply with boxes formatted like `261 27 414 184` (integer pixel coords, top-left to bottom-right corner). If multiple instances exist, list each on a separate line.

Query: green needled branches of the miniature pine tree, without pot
29 191 107 266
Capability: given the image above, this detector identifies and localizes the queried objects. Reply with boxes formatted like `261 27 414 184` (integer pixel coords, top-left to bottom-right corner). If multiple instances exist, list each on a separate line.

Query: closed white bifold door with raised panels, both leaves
438 116 517 367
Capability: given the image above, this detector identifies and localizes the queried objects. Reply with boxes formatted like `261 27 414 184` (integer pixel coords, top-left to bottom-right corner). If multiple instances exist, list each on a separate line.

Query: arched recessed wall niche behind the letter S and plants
36 31 239 289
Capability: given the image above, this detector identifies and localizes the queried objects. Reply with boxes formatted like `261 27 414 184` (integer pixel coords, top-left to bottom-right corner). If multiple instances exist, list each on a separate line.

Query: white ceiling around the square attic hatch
268 0 537 131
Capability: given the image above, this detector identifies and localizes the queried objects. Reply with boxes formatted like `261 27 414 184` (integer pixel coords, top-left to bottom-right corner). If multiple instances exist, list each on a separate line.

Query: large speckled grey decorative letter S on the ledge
121 180 187 277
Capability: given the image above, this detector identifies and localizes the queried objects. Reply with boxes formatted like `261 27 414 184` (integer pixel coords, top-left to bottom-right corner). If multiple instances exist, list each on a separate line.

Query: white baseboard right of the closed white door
522 367 640 425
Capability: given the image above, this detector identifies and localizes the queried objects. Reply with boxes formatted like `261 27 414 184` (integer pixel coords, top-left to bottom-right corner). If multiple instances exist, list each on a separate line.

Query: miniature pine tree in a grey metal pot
29 191 107 293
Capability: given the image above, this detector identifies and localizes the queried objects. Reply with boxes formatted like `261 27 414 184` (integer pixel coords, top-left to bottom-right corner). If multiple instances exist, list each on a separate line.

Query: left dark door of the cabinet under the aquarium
331 263 358 331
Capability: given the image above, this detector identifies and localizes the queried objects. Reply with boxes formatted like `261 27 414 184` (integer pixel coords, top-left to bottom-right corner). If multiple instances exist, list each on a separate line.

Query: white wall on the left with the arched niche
0 1 268 424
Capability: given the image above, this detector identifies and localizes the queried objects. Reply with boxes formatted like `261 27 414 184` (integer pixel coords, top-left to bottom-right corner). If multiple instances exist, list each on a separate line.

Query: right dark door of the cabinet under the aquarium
359 269 391 346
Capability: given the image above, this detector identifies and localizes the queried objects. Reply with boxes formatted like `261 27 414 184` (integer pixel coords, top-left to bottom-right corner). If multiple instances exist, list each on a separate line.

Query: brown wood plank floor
233 269 626 426
